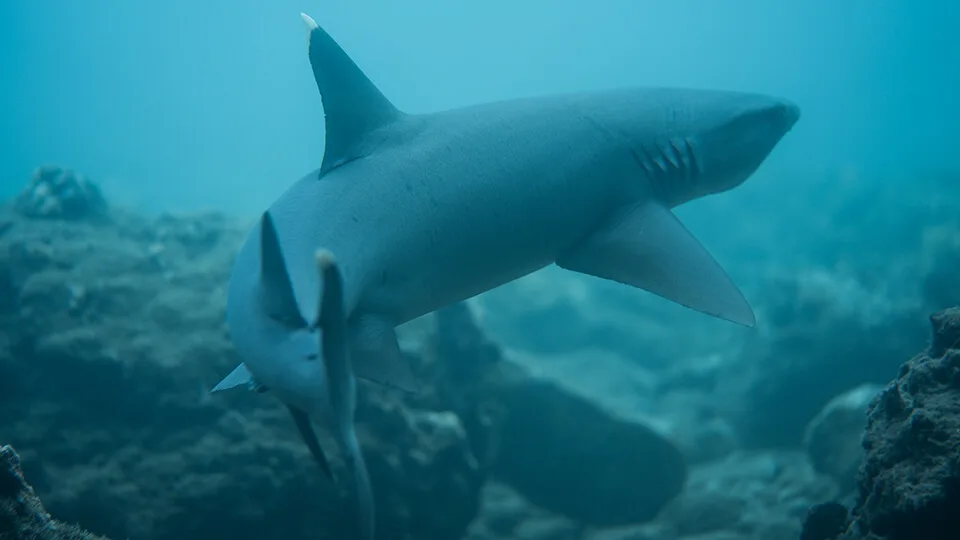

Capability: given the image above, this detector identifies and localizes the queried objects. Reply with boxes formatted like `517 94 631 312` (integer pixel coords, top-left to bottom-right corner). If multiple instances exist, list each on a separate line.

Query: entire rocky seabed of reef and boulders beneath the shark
0 167 960 540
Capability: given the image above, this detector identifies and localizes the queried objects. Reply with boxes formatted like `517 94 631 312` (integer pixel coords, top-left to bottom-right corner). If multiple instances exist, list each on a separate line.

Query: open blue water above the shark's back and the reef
0 0 960 214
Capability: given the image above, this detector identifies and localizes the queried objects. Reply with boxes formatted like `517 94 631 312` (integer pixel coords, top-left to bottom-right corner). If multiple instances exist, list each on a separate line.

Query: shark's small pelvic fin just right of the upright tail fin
348 315 420 392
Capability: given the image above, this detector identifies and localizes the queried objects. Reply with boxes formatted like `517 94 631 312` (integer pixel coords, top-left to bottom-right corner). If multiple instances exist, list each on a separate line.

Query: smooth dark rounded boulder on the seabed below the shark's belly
493 378 686 525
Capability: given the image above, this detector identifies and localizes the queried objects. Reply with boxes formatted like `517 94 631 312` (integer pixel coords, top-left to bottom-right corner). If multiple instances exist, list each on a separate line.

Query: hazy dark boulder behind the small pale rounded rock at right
728 269 926 449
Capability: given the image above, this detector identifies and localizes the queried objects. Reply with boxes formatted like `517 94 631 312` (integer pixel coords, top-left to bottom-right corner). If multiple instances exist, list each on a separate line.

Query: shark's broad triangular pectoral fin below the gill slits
557 201 756 326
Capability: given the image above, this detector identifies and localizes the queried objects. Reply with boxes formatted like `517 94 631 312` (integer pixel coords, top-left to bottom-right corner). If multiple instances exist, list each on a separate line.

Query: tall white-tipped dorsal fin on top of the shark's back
300 13 403 172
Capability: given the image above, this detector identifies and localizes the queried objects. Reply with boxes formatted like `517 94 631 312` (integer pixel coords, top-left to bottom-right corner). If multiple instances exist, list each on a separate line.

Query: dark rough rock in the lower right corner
808 308 960 540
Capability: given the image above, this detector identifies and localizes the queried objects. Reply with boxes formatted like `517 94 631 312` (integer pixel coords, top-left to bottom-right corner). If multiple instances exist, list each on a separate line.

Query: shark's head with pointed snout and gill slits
608 88 800 206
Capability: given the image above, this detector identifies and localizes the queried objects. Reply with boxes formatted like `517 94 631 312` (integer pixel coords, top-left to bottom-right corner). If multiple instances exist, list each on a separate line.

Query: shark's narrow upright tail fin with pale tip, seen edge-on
316 250 375 540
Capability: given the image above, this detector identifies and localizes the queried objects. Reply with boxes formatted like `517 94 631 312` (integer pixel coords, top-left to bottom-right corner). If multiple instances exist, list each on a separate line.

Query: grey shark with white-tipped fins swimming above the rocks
212 10 800 540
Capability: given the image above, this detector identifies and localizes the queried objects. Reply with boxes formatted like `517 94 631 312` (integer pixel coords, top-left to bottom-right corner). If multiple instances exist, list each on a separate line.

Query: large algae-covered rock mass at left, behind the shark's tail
0 196 483 540
